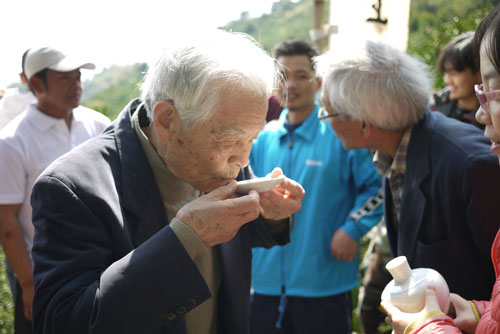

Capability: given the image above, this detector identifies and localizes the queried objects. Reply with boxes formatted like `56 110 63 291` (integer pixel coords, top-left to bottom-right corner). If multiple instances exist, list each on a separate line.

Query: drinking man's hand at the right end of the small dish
260 168 305 220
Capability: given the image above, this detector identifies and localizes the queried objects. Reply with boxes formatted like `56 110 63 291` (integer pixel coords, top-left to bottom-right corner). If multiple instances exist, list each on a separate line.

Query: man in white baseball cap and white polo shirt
0 47 110 333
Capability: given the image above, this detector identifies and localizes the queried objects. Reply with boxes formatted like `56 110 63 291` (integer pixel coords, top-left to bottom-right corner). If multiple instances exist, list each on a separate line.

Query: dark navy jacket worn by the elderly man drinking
31 100 289 334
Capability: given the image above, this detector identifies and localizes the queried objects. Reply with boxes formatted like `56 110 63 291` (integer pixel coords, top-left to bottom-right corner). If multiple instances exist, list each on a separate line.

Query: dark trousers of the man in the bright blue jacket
250 292 352 334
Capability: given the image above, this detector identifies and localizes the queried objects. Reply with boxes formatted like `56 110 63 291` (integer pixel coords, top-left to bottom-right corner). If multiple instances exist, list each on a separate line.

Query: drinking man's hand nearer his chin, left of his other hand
176 181 259 247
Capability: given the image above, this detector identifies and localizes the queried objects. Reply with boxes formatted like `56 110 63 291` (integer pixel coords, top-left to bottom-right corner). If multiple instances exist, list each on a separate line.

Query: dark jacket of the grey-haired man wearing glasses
384 112 500 300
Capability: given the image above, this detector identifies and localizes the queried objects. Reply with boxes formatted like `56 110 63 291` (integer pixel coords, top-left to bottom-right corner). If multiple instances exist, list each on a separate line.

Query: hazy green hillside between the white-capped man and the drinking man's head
82 63 147 119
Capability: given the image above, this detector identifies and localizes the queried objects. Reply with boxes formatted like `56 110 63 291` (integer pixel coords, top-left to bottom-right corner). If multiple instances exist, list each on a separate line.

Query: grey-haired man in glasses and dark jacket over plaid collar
321 42 500 299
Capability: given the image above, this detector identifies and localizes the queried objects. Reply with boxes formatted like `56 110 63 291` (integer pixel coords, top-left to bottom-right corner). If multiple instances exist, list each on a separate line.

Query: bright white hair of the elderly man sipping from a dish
141 30 279 128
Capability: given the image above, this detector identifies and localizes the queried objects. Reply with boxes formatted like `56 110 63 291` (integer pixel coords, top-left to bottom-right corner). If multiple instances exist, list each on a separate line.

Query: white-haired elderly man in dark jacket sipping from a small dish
31 31 304 334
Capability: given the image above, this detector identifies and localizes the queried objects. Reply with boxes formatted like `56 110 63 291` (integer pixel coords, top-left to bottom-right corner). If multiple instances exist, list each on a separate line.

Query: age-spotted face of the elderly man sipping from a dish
160 88 267 192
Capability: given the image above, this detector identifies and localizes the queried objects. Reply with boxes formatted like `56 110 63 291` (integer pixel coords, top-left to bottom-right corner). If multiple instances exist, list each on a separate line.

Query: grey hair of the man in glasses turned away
316 42 432 131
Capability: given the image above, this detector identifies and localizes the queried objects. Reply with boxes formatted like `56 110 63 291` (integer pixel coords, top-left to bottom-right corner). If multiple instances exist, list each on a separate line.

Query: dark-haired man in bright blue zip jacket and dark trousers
250 41 382 334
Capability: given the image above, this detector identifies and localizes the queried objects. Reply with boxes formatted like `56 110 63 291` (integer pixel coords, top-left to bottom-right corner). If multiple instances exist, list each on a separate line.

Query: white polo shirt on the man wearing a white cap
0 104 110 253
